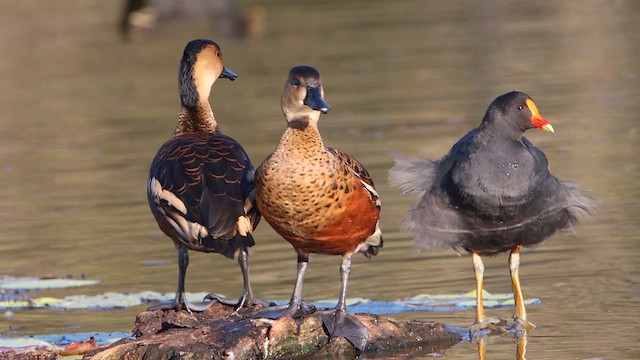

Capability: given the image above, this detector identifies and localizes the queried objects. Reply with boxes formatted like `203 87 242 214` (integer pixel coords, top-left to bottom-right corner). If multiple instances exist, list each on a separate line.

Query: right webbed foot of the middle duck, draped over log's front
320 309 369 351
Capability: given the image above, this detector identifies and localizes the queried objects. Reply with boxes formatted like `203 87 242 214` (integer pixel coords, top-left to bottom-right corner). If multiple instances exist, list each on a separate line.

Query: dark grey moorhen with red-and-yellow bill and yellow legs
389 91 598 332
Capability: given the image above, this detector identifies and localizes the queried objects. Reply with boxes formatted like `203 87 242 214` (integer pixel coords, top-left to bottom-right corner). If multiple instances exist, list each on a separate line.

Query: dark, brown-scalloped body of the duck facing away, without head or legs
149 135 260 255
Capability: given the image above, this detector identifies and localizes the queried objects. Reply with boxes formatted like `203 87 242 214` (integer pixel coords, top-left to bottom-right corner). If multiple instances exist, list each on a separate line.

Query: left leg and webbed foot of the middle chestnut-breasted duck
249 252 316 319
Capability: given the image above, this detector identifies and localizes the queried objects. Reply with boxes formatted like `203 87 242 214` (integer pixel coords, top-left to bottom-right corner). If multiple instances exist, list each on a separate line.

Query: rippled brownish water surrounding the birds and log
0 0 640 359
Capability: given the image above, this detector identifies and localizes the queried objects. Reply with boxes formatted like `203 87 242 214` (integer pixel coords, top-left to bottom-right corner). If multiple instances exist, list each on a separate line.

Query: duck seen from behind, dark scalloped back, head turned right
147 39 260 312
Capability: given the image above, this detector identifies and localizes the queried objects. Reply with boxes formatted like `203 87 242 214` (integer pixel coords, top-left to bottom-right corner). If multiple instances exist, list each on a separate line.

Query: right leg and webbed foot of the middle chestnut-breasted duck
320 254 369 350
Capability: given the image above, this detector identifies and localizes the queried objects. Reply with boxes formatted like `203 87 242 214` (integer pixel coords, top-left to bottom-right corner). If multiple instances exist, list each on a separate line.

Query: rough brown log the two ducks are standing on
85 304 468 360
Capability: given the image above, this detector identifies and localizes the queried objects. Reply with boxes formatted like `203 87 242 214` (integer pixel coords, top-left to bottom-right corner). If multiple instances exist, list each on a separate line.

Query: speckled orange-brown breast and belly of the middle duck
256 148 380 255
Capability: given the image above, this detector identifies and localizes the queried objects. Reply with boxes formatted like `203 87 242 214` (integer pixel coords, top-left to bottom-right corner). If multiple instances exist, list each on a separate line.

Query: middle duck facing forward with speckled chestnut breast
253 66 383 350
